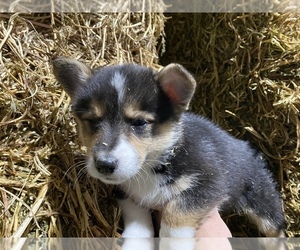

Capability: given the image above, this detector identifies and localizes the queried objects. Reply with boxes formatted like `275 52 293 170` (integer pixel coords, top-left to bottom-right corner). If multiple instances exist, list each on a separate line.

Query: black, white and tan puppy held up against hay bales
53 57 284 238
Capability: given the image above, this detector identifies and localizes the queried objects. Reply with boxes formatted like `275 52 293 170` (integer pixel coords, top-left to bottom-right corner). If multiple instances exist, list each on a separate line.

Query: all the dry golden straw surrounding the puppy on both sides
0 13 300 237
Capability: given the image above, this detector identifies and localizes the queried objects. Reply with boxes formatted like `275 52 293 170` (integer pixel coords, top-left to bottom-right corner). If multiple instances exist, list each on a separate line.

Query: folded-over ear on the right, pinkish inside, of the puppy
157 63 196 112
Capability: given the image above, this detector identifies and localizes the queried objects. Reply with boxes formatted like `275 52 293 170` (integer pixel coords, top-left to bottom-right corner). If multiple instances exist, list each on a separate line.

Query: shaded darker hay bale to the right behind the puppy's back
162 13 300 236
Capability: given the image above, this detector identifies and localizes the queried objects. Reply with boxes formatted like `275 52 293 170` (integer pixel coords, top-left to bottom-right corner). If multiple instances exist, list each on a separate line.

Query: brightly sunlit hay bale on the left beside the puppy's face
0 13 165 237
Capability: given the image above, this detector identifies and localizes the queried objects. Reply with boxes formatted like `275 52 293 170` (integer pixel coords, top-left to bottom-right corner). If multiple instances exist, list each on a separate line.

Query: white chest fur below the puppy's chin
122 166 186 210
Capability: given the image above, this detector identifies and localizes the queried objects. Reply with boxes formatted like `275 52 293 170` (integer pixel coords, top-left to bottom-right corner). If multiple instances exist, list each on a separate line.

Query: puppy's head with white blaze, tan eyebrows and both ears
53 57 196 184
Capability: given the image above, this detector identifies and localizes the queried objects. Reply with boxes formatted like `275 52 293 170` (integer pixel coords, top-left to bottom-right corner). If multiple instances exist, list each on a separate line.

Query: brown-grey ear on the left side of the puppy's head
52 57 92 98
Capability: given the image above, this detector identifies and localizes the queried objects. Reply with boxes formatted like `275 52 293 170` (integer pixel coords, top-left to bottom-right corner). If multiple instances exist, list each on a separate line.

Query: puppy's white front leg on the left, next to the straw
118 198 154 238
